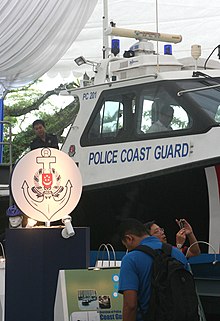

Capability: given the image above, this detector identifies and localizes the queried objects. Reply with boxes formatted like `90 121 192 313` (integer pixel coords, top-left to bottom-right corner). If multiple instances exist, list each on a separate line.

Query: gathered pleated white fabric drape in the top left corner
0 0 97 89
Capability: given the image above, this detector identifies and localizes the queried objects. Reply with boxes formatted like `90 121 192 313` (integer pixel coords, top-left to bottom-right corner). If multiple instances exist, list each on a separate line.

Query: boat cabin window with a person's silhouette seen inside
137 90 192 134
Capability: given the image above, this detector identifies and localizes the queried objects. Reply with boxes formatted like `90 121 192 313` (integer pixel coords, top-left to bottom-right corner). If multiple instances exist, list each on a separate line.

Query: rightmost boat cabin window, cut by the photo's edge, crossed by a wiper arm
178 78 220 123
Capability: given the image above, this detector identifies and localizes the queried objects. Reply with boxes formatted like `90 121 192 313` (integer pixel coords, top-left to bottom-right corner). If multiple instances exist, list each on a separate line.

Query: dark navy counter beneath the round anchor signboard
5 227 90 321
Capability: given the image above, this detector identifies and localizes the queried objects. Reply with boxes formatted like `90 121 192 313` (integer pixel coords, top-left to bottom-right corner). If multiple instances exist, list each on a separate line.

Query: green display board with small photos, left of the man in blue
54 268 122 321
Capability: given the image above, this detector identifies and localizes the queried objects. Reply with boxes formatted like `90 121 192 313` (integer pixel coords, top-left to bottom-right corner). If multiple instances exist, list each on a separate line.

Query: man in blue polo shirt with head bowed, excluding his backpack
119 218 187 321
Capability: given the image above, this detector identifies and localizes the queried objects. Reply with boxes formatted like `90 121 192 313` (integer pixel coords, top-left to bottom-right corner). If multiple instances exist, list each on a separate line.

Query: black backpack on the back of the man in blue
135 243 199 321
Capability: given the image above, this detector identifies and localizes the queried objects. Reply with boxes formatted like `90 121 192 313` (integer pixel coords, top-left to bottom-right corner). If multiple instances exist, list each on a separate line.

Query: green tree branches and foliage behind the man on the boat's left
3 82 79 163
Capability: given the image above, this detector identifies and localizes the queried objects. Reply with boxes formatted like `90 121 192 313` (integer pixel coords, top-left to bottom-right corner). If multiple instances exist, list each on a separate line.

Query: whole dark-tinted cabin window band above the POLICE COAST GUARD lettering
81 79 217 146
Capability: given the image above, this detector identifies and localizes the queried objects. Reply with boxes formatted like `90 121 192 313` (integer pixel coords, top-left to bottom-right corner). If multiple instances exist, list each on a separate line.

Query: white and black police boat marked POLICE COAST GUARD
59 11 220 255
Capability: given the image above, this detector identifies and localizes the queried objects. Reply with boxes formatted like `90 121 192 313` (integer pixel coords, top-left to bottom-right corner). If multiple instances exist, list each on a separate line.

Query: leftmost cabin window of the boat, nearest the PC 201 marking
86 88 136 144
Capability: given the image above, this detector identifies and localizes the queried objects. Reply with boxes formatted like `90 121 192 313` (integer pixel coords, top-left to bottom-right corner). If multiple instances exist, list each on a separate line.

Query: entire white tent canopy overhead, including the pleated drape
0 0 220 88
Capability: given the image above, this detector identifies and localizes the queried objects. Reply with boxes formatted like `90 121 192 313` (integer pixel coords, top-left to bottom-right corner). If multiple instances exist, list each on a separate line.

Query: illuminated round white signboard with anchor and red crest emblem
11 148 82 222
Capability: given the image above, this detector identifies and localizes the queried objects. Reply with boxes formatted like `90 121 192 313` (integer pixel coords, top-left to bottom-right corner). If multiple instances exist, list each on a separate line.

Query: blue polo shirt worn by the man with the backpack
118 236 187 321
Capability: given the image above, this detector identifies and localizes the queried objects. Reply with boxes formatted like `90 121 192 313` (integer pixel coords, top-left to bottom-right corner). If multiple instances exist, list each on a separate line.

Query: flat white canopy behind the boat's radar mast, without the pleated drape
47 0 220 78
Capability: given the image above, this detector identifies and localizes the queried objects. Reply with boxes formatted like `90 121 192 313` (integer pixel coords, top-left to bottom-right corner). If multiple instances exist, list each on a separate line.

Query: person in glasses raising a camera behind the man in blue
144 219 201 257
